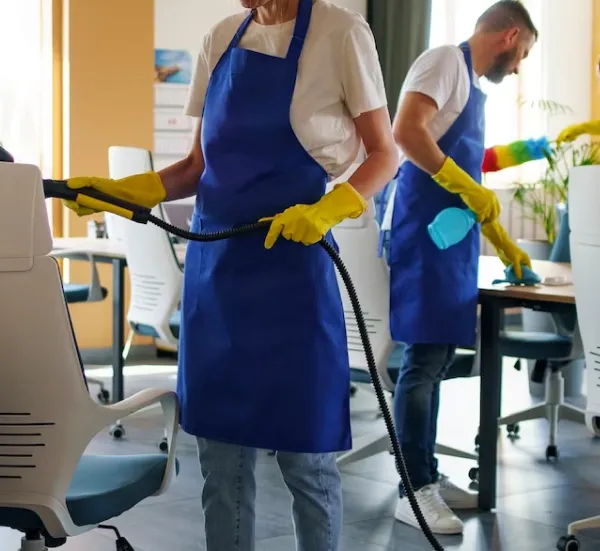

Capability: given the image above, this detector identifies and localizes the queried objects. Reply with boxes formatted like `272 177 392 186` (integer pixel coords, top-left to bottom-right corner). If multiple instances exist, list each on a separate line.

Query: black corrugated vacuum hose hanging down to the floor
148 215 444 551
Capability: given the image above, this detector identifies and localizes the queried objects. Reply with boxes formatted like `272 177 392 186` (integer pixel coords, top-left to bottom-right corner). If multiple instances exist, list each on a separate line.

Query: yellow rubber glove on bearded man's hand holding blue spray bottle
433 157 501 222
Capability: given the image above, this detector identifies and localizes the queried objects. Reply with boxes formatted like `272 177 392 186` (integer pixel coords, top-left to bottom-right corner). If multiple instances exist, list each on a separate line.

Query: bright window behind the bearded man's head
429 0 547 187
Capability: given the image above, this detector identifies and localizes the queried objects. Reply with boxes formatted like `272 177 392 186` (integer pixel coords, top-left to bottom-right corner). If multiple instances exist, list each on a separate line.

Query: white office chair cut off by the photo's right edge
559 166 600 551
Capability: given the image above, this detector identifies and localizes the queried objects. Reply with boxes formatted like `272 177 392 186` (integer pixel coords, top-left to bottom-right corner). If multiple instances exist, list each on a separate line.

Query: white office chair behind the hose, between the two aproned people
333 207 477 476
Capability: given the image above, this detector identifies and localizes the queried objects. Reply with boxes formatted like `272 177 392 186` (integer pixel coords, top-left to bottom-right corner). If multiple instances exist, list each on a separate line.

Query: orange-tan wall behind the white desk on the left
62 0 154 348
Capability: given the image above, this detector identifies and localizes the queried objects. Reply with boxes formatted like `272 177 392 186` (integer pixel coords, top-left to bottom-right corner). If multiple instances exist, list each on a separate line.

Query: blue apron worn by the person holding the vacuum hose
177 0 352 453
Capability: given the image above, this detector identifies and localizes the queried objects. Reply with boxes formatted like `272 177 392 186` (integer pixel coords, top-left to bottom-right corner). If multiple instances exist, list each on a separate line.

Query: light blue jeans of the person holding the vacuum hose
198 438 342 551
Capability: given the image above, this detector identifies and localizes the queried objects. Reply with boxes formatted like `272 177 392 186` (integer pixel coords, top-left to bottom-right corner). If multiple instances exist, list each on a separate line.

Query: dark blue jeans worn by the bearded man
394 344 457 497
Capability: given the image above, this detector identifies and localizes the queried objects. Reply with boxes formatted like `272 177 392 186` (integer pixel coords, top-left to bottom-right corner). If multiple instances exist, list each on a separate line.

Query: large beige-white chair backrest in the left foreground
0 163 107 536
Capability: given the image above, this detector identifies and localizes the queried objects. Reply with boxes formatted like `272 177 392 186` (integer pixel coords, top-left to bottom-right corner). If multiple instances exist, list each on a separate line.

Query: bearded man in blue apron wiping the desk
390 0 537 534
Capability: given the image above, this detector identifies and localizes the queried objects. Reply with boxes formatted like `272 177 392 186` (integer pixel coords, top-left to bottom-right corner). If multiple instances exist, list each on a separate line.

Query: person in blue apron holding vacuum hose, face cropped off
64 0 398 551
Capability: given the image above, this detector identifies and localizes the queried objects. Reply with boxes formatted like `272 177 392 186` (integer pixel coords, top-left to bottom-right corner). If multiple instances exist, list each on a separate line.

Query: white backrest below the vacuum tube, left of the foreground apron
120 205 183 344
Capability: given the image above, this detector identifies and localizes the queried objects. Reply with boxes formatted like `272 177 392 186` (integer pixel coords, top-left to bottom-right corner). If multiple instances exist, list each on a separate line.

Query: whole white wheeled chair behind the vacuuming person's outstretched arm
109 146 183 451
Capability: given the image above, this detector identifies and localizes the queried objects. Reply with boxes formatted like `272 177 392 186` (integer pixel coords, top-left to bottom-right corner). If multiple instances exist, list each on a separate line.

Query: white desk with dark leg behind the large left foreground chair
51 237 186 402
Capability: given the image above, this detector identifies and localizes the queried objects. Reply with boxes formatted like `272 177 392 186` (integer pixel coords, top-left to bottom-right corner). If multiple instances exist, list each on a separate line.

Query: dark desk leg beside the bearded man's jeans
479 298 502 511
